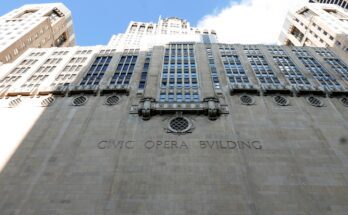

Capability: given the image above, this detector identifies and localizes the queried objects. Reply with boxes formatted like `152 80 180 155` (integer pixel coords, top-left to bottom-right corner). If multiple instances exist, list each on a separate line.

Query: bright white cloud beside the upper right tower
198 0 308 44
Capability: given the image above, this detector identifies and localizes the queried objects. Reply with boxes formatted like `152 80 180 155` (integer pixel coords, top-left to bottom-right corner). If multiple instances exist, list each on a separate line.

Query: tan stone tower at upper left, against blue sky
0 3 75 64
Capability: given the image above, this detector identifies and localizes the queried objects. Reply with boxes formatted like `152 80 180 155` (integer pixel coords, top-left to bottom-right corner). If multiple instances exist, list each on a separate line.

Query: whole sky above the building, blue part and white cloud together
0 0 306 46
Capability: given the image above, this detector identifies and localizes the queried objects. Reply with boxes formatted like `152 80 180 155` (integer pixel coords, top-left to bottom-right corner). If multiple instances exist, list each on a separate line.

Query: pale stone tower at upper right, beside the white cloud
279 3 348 56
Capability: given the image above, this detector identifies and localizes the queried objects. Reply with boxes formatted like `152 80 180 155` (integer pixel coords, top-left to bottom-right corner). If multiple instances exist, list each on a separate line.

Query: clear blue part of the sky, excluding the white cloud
0 0 232 45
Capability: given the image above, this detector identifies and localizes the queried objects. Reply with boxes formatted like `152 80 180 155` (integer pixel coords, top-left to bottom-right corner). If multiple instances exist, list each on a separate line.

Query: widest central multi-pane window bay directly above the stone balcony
159 44 200 102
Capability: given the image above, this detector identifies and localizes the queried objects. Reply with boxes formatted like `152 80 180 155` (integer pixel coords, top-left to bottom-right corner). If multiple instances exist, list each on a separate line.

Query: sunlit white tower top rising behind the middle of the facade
108 17 217 50
